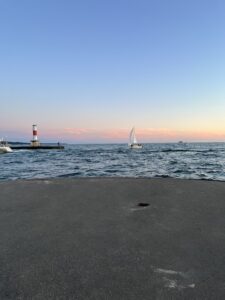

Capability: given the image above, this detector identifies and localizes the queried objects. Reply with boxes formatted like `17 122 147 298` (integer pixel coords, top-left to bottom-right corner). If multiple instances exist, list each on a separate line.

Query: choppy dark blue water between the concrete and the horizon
0 143 225 181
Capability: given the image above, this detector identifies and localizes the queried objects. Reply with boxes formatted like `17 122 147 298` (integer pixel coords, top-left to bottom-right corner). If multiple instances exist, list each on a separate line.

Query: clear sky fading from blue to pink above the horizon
0 0 225 143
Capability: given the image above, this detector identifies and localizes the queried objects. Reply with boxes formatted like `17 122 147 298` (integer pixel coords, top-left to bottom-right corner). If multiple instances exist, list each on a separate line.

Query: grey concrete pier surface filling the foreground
0 178 225 300
